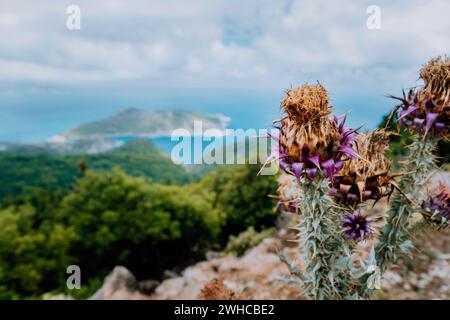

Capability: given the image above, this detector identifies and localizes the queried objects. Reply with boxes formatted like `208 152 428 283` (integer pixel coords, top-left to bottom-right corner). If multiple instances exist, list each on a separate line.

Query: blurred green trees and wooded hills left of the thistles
0 141 277 299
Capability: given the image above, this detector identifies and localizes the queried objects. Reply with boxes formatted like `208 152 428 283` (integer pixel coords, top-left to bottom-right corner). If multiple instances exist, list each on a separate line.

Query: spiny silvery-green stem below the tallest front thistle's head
298 179 349 299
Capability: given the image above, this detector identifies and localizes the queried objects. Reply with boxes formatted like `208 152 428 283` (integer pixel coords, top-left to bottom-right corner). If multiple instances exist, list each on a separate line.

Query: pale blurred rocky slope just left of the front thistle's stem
151 238 299 300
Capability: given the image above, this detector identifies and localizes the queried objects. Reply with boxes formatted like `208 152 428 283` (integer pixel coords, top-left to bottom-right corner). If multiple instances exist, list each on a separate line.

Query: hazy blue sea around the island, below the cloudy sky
0 88 392 144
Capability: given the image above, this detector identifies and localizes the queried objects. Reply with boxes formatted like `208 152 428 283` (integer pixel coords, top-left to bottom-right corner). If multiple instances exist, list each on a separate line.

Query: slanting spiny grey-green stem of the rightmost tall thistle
375 135 437 272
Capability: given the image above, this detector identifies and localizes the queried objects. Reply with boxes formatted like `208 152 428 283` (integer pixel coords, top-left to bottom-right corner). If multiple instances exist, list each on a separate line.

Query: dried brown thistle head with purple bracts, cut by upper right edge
393 57 450 138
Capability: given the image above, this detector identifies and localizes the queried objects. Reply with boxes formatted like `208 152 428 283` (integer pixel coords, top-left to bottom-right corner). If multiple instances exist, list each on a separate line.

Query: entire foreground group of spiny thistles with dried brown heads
271 58 450 299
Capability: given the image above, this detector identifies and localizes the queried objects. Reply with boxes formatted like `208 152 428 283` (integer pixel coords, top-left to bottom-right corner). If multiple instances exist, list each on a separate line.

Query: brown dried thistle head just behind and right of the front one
332 129 393 204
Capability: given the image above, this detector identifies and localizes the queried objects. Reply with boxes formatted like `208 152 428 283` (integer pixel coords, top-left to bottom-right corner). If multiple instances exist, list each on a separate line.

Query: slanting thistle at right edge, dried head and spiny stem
376 58 450 272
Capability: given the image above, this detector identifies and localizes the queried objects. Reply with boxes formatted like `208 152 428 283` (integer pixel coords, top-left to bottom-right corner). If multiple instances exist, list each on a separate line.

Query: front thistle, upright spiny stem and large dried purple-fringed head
270 84 357 299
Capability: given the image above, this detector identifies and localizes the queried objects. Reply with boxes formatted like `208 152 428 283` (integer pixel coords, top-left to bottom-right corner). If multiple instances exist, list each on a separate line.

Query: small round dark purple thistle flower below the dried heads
342 210 374 242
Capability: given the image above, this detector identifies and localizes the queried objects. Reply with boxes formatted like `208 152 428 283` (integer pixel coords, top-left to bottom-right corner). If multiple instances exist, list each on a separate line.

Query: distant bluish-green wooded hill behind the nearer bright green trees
0 140 190 199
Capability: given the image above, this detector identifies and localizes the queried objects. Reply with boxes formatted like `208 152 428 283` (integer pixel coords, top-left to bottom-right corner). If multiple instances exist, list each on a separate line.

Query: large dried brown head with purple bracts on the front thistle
278 84 357 179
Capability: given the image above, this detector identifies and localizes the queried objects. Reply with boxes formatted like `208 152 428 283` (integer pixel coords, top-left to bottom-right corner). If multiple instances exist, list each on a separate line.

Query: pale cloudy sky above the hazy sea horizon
0 0 450 88
